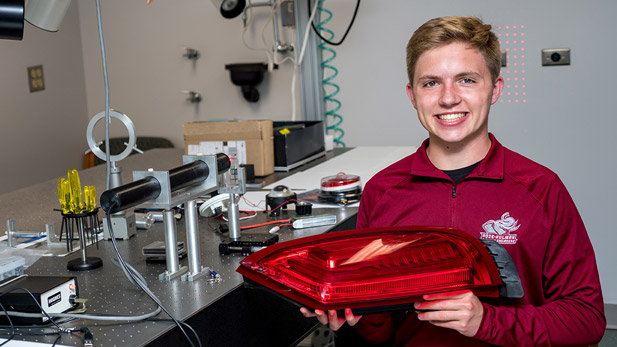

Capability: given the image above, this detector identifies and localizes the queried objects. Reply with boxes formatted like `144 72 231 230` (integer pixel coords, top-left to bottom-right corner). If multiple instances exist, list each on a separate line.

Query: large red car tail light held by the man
237 227 502 310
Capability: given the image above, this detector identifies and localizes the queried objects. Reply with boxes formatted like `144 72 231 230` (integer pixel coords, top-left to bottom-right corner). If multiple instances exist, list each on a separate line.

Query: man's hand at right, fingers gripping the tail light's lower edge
414 290 484 337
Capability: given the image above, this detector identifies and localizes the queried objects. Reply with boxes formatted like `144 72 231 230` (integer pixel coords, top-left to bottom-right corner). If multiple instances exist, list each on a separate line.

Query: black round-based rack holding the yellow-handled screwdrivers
60 208 103 271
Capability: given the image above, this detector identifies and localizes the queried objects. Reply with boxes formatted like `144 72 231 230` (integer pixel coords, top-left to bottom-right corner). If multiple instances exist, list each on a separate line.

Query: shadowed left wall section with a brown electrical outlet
0 4 88 194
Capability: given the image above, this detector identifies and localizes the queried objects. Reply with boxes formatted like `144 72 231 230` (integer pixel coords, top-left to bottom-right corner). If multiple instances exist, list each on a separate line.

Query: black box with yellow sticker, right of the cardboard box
274 121 326 171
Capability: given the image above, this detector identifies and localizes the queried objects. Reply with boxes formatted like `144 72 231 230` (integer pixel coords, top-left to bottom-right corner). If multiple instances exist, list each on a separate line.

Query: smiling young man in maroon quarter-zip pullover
302 17 606 346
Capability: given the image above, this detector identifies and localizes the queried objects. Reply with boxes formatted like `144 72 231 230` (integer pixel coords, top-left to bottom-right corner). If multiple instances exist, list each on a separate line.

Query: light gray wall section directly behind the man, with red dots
327 0 617 303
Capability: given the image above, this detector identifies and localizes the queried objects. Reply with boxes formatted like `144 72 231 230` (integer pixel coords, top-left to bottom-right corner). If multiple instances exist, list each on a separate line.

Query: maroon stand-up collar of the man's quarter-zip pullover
410 133 505 180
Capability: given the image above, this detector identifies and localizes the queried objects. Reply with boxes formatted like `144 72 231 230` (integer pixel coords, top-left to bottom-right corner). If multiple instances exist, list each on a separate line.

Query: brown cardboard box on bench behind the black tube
183 120 274 176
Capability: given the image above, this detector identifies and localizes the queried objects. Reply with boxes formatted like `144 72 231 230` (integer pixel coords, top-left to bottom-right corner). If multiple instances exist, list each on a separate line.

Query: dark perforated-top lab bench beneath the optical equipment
0 149 357 346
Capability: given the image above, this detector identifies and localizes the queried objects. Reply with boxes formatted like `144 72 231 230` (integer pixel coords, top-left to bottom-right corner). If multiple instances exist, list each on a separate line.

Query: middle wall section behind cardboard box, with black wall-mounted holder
79 0 294 147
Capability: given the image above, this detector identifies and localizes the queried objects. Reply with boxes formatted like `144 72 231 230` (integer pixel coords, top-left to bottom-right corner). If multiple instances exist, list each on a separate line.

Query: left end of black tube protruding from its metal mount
101 176 161 214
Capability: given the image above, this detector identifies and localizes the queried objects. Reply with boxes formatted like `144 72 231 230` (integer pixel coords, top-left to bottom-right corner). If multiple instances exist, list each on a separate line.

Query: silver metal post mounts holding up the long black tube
133 155 218 281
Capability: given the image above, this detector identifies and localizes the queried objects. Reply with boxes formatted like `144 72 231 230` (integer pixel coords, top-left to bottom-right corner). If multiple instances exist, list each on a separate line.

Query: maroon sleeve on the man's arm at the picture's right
475 180 606 346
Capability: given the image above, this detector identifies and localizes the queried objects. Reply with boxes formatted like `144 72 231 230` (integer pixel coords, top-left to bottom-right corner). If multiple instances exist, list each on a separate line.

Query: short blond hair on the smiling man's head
407 17 501 85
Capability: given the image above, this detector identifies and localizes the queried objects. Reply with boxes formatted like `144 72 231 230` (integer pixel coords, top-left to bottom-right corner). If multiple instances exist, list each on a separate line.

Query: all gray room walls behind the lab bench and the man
0 0 617 303
